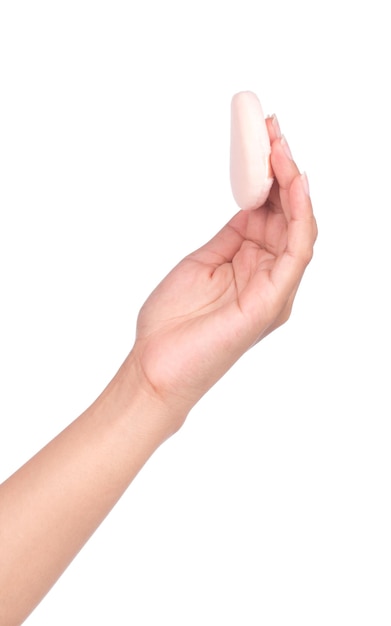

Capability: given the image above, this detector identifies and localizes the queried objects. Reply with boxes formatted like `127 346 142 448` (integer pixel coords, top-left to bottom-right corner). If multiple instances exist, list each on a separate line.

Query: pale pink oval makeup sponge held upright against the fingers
230 91 273 210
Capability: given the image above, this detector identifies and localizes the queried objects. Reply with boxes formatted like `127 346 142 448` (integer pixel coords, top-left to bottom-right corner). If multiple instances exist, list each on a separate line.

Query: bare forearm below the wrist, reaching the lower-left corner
0 358 182 626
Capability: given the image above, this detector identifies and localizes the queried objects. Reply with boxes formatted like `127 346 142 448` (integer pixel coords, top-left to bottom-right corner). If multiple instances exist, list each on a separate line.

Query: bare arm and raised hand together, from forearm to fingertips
0 117 317 626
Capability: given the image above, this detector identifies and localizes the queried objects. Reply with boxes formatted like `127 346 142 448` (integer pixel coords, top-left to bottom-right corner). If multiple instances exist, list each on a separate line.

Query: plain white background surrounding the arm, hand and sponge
0 0 391 626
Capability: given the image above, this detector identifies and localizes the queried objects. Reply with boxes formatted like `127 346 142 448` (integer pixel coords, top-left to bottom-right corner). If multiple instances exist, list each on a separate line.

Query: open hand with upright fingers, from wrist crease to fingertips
132 118 317 419
